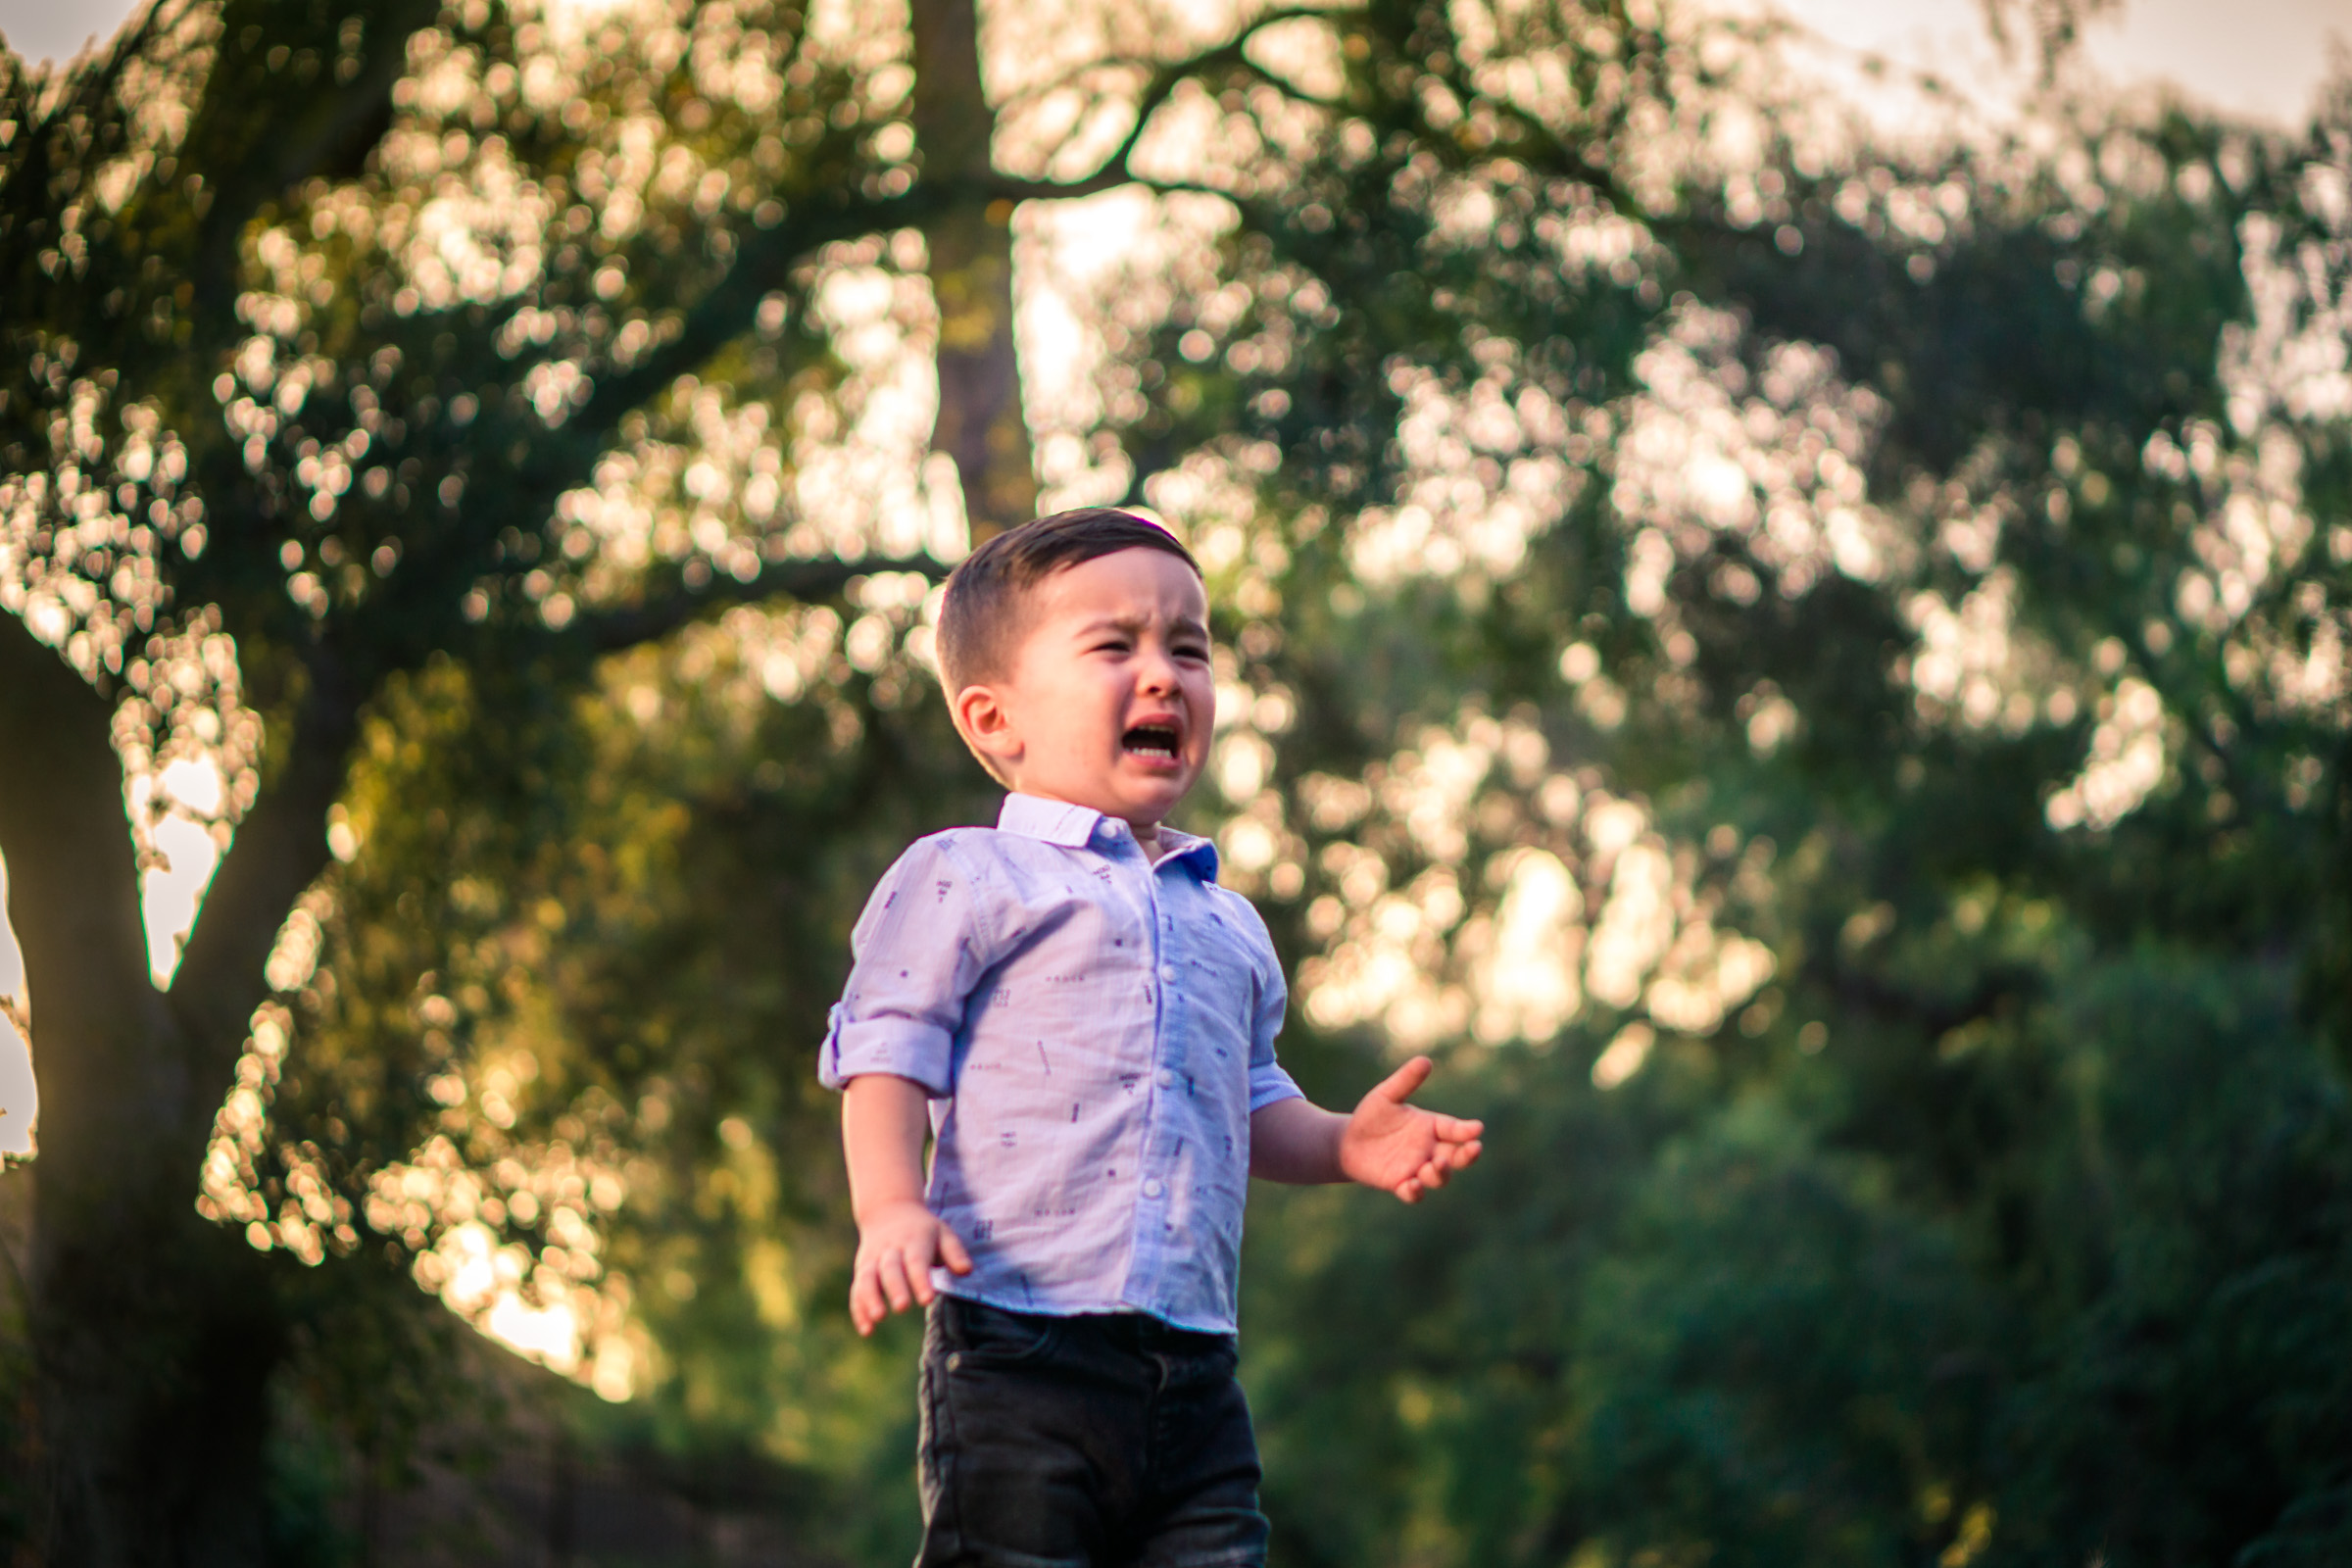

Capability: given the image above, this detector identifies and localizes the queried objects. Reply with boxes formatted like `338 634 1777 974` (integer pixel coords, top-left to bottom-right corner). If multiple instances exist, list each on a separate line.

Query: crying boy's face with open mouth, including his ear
955 548 1216 839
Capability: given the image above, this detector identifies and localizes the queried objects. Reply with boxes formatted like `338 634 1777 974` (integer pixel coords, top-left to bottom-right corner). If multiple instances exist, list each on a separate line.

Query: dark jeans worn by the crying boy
915 1296 1265 1568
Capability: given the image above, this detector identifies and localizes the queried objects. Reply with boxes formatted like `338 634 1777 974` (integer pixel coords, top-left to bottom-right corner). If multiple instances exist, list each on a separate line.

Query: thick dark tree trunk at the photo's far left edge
0 615 280 1568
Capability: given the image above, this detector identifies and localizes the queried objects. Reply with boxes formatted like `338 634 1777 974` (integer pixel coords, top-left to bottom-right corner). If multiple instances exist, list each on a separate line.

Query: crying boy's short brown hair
939 506 1200 706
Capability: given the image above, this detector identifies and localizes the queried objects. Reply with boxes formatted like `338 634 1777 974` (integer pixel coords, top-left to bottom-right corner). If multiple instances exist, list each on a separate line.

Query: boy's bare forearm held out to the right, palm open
1249 1055 1487 1203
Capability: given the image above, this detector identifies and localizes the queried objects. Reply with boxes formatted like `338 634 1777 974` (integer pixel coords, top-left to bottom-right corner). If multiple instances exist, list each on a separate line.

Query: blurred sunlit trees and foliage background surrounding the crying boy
0 0 2352 1568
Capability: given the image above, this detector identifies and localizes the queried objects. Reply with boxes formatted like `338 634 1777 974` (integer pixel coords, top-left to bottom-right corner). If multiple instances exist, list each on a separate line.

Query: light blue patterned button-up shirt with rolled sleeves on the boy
818 795 1298 1333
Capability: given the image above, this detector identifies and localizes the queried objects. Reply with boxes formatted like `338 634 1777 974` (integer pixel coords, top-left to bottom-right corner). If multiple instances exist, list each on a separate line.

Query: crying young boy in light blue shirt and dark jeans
821 511 1482 1568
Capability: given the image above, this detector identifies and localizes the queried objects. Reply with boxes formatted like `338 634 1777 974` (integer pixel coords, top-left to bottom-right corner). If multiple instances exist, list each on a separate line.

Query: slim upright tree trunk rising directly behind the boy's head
912 0 1037 543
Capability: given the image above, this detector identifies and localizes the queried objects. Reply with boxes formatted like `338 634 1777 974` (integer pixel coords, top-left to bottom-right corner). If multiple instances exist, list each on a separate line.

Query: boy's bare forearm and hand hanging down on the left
842 1072 971 1333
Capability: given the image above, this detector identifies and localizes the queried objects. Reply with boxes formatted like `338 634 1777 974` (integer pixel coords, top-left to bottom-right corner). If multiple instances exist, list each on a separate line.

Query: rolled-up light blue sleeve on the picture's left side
816 839 995 1098
